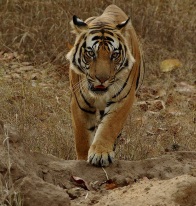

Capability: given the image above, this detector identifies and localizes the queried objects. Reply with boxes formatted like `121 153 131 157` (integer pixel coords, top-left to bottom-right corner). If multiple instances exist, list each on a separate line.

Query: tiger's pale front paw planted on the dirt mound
88 145 115 167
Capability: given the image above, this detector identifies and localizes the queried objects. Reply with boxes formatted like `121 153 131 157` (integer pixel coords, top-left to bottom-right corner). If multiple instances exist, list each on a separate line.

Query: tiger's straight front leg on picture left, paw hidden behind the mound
71 96 96 160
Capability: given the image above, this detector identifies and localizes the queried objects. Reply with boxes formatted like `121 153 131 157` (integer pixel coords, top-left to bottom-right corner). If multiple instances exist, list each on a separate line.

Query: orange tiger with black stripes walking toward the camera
66 5 144 167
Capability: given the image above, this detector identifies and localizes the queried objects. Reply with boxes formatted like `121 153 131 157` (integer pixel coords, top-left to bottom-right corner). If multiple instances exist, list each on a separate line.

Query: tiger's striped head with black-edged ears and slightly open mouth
67 16 135 95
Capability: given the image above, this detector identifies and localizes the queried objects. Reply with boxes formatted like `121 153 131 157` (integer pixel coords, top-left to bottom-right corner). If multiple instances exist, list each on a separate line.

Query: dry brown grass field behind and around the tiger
0 0 196 162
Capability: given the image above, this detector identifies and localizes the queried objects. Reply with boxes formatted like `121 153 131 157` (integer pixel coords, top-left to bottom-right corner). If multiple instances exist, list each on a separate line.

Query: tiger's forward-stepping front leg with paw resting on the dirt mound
88 91 134 166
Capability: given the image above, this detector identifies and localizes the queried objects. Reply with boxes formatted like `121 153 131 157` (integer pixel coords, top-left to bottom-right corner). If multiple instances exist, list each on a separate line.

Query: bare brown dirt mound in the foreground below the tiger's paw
0 122 196 206
